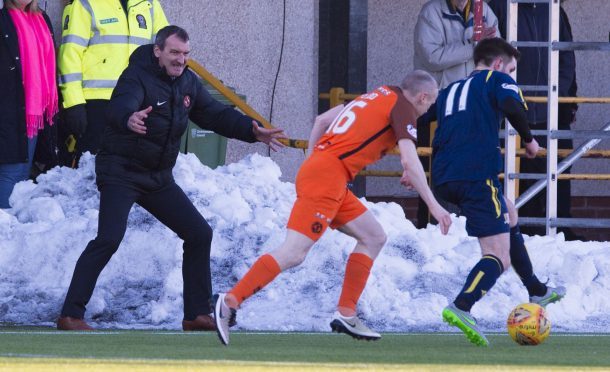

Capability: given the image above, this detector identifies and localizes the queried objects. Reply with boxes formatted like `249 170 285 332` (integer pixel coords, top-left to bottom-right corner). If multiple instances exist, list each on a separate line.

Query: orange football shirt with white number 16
314 85 417 178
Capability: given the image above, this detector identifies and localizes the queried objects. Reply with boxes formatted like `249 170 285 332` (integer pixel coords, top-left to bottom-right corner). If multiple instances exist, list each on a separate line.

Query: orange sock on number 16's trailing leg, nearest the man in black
229 254 282 306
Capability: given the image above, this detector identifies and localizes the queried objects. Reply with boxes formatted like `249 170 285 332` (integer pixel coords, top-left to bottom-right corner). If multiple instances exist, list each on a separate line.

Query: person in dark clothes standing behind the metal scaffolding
489 0 583 240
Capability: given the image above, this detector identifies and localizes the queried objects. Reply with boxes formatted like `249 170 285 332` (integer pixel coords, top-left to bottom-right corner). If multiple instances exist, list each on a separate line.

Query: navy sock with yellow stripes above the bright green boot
453 254 504 311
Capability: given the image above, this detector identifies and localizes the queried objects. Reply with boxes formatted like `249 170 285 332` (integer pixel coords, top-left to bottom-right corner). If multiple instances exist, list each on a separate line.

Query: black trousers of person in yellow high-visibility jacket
58 99 109 167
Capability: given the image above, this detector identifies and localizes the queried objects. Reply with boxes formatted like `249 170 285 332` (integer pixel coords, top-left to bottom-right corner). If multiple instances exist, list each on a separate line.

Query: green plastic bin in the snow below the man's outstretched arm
180 82 246 168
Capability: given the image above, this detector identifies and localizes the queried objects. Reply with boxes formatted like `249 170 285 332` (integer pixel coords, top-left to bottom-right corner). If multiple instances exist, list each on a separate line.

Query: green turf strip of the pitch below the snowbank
0 327 610 369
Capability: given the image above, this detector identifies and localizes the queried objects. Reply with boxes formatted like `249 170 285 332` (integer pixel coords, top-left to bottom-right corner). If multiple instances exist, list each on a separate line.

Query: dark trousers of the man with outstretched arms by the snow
61 180 212 320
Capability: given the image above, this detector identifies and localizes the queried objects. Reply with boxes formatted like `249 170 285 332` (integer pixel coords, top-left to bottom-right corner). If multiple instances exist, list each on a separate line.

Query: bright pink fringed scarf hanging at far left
9 9 57 138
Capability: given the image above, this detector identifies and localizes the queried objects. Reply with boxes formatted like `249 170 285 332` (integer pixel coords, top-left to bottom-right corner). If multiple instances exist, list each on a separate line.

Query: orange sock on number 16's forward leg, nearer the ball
339 253 373 315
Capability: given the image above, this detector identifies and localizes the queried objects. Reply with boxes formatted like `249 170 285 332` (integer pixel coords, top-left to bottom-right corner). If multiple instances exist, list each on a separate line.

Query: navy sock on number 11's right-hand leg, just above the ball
510 225 546 296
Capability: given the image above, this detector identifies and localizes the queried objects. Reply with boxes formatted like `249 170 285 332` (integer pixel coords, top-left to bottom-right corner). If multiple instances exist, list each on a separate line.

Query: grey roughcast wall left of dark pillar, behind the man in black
41 0 318 180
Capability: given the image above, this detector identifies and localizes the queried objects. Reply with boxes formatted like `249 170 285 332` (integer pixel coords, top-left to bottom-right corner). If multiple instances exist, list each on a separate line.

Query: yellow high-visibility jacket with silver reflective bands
58 0 168 108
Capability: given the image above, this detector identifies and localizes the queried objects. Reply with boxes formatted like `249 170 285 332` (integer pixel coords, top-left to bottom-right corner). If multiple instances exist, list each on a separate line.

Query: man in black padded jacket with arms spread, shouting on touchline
57 26 285 331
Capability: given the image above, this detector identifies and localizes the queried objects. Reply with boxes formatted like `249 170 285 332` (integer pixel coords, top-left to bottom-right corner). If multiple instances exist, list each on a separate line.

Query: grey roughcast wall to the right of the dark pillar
367 0 610 196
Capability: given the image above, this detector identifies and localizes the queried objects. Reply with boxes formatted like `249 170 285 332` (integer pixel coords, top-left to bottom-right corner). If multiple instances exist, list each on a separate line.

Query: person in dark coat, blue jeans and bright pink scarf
0 0 58 208
